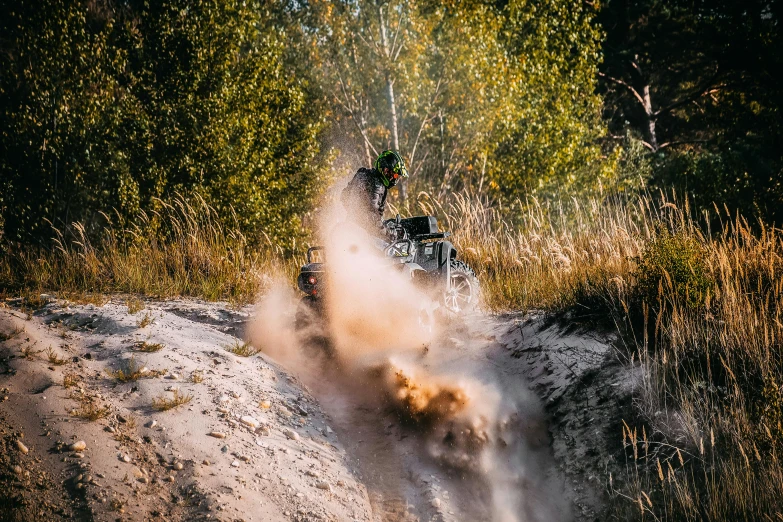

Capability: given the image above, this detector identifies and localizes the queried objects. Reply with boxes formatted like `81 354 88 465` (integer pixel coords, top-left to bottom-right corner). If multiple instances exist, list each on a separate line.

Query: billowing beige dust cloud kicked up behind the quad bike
247 180 569 522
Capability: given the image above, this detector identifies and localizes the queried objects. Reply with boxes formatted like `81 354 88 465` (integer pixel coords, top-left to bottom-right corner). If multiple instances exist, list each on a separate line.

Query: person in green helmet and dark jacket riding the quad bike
340 150 408 236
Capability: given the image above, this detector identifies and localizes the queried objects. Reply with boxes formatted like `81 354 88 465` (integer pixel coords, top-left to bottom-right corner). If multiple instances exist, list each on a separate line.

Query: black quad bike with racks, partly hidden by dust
297 215 479 314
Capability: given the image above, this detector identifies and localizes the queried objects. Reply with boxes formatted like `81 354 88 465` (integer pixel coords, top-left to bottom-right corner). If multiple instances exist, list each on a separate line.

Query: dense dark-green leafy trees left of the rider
0 0 324 246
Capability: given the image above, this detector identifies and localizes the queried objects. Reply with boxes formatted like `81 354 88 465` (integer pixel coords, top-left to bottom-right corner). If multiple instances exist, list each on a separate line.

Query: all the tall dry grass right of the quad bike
419 190 783 522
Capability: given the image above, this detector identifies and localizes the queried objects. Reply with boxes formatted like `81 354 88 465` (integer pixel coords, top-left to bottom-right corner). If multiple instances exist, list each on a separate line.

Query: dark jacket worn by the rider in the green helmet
340 168 389 234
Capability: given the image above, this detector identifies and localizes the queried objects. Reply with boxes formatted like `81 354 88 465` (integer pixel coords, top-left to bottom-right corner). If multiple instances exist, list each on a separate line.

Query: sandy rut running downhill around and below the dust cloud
278 308 572 522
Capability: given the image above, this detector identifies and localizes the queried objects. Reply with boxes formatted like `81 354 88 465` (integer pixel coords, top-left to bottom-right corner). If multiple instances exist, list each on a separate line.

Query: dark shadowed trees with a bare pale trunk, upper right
598 0 783 223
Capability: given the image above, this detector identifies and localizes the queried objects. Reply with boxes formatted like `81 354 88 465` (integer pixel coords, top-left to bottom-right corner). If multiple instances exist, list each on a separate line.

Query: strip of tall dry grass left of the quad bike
0 197 296 302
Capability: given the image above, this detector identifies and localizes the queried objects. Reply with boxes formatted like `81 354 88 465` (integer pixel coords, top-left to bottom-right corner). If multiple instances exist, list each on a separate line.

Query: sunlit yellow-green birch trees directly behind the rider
303 0 611 202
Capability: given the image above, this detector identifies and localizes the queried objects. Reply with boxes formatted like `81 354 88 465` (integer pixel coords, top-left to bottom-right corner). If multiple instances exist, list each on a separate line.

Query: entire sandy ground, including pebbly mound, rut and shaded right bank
0 299 635 522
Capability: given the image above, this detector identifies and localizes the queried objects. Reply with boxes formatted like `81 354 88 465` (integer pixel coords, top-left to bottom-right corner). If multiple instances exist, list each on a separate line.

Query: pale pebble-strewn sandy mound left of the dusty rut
0 296 370 522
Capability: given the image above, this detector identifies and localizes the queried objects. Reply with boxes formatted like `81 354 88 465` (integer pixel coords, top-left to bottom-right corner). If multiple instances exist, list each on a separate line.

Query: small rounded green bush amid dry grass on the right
634 227 713 308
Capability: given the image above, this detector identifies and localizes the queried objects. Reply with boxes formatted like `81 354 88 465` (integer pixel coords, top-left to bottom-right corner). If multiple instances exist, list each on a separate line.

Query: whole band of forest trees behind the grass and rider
0 0 783 248
